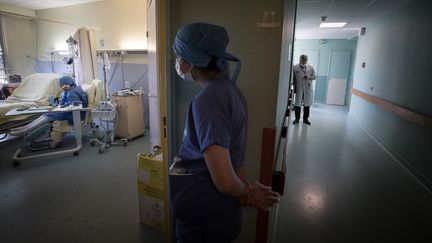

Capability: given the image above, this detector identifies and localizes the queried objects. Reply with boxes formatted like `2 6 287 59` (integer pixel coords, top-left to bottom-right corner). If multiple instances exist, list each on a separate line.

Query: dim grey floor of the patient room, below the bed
0 135 164 243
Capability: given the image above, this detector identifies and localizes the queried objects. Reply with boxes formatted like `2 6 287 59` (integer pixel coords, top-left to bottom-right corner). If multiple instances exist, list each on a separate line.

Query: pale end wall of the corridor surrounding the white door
294 37 357 104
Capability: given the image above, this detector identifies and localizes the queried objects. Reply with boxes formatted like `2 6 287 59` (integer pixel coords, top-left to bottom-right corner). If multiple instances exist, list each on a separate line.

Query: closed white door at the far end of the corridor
326 51 351 105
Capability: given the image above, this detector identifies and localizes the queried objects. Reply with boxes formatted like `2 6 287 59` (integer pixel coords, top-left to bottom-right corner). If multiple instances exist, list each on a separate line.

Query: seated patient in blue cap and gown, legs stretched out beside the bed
9 76 88 140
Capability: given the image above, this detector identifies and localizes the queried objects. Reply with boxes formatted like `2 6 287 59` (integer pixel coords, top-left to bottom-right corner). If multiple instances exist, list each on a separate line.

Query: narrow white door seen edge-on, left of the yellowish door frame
147 1 161 146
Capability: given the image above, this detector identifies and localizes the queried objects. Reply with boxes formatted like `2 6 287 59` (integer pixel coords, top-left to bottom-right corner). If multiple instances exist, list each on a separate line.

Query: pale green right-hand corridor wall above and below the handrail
349 0 432 185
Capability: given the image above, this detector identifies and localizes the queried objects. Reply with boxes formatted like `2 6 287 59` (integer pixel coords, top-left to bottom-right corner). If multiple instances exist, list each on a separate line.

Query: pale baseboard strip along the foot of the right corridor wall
348 115 432 194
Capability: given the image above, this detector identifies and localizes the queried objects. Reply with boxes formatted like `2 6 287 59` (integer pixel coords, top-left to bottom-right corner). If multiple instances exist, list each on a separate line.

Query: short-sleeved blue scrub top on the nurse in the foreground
177 80 247 169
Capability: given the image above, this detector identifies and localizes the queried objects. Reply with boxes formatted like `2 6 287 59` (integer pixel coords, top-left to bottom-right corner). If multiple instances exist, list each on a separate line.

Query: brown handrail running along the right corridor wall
352 89 432 132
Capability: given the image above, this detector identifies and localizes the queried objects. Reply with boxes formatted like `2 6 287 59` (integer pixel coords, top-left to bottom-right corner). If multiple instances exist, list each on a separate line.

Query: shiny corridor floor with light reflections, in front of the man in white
272 104 432 243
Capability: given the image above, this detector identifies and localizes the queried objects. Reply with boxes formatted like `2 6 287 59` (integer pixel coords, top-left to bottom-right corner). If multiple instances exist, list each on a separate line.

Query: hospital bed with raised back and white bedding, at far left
0 73 61 139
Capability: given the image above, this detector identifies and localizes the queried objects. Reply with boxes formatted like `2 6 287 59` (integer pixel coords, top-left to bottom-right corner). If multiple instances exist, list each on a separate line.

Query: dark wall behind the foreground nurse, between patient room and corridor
170 0 292 242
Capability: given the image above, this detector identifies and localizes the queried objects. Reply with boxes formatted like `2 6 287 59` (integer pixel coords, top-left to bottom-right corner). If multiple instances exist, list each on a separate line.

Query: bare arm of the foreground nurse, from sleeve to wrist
204 144 245 197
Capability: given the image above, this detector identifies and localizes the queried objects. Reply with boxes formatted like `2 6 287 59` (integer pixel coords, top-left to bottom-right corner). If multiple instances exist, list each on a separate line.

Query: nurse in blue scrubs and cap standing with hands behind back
170 23 279 243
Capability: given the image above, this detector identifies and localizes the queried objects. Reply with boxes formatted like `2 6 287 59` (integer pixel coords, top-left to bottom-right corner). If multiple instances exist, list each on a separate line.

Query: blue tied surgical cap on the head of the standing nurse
173 23 241 82
